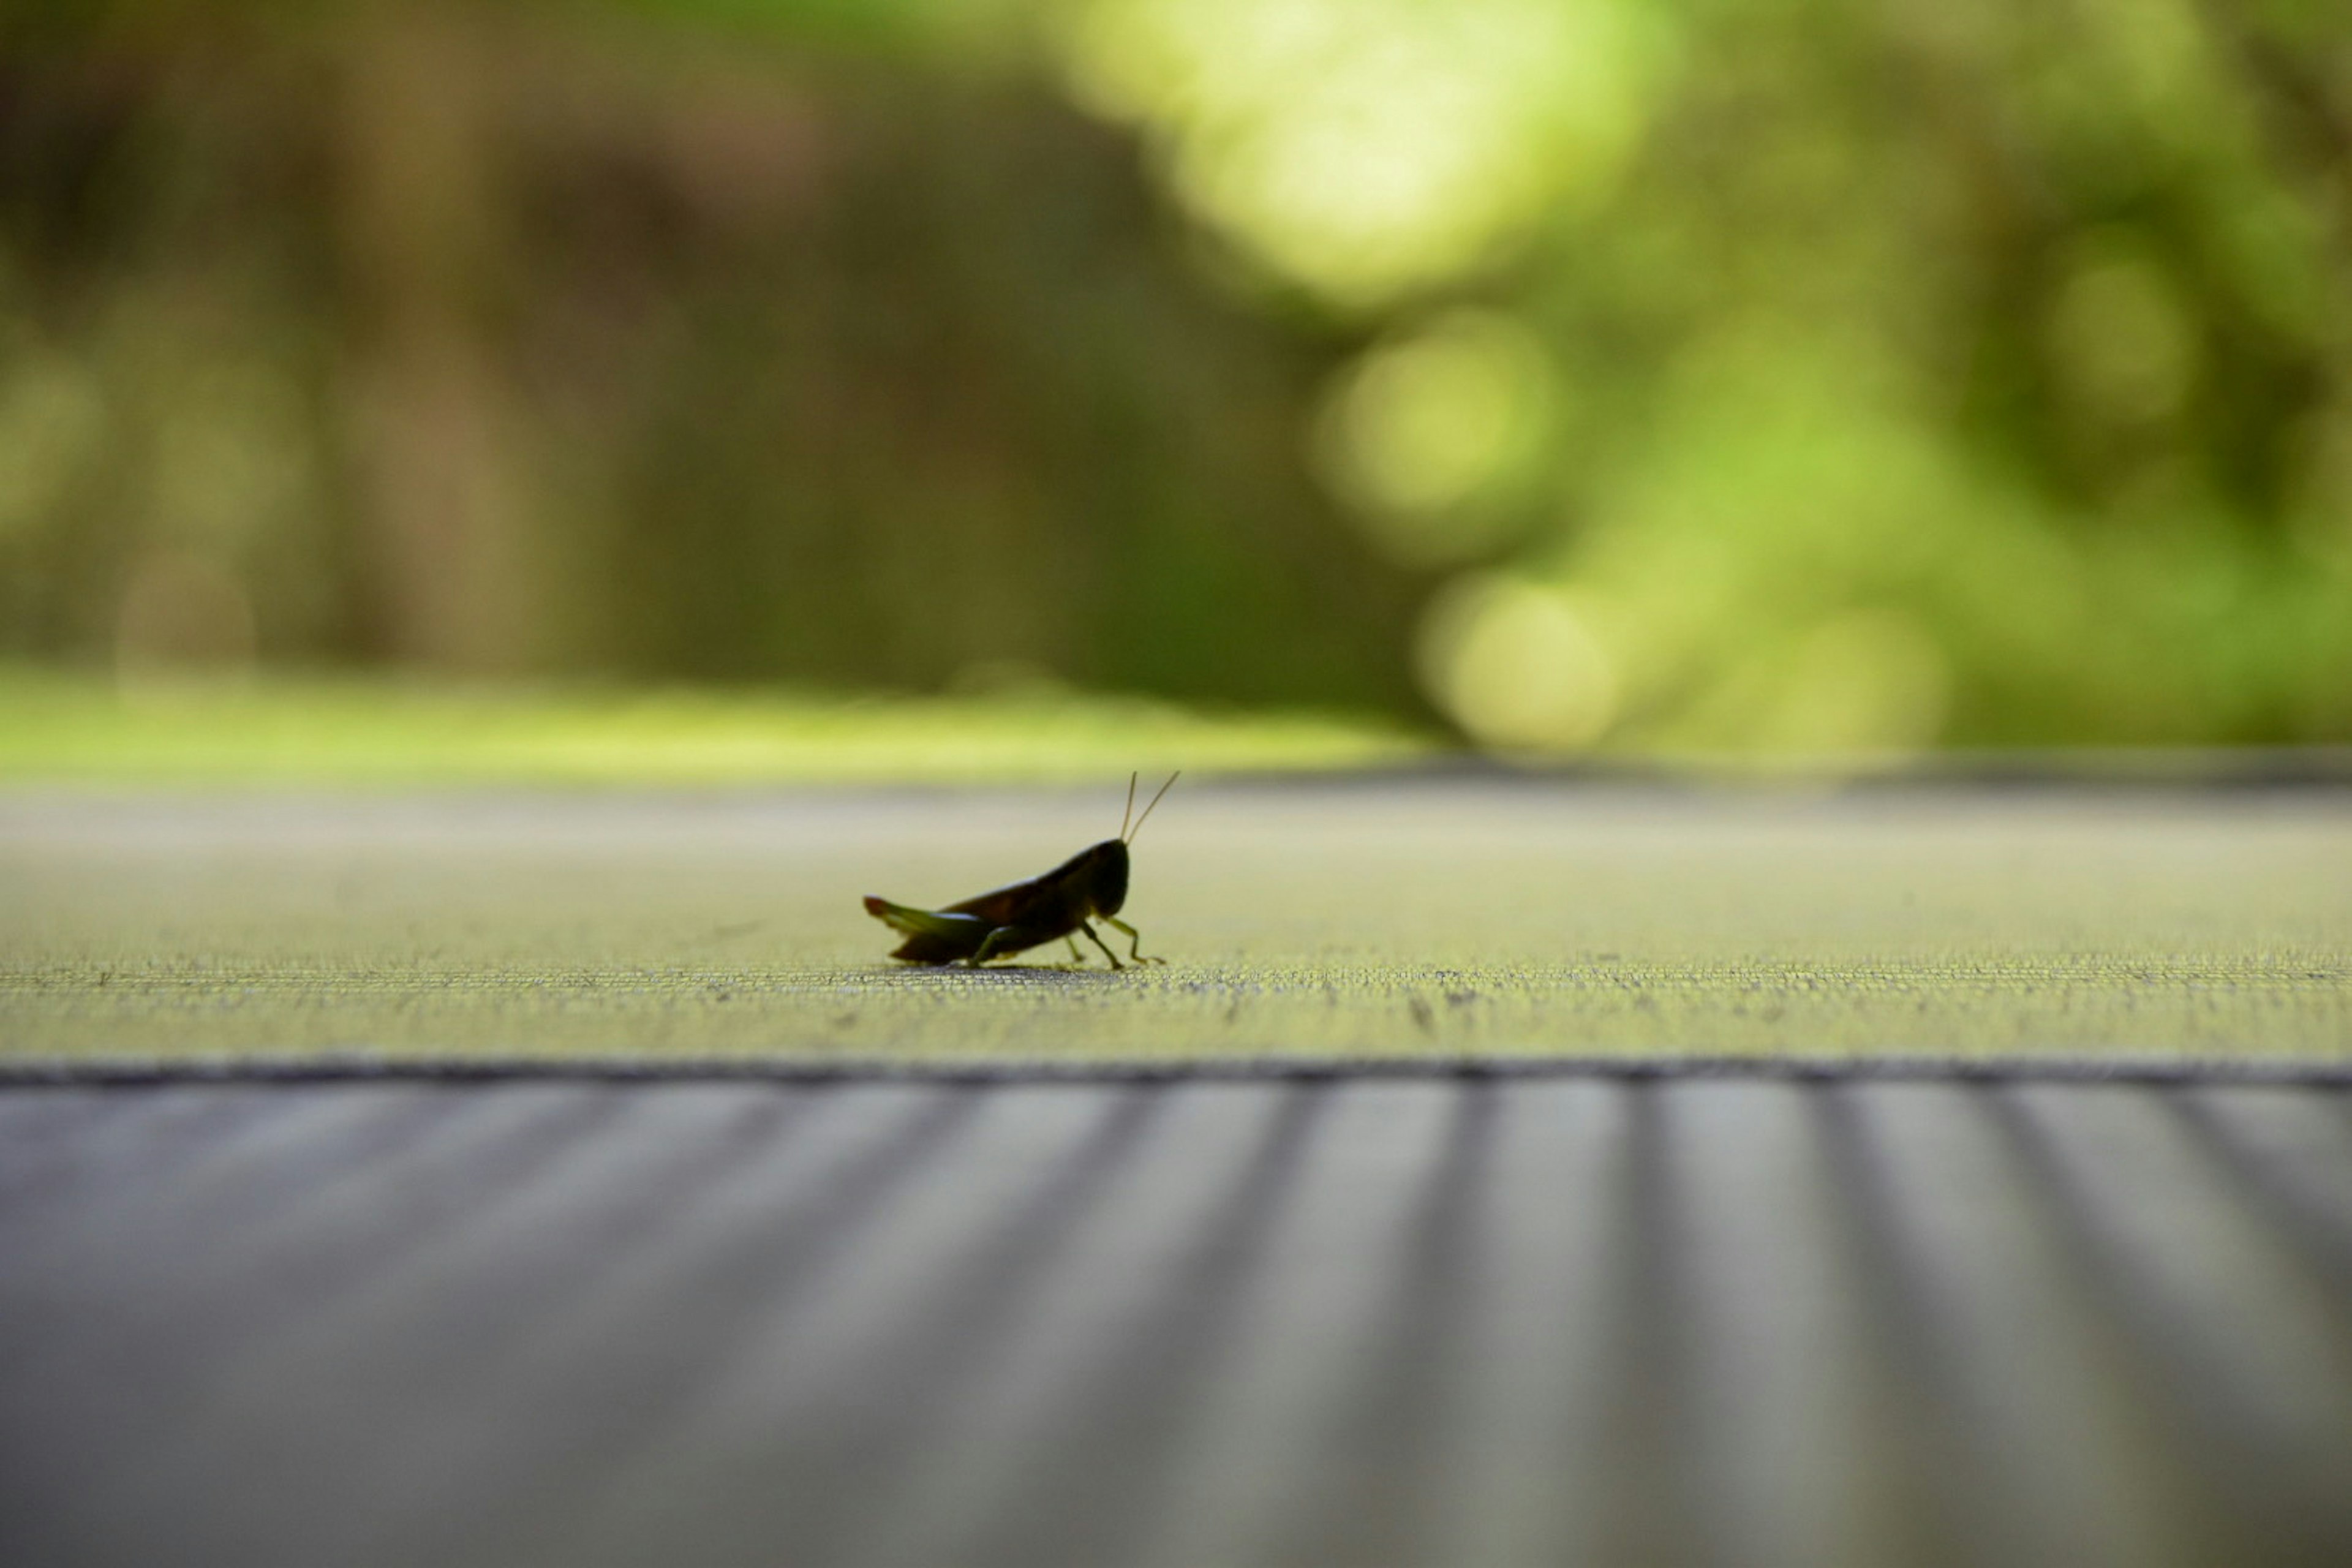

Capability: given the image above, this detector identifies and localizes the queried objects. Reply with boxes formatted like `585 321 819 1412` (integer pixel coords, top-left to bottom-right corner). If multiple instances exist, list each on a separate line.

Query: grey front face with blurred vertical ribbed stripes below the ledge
0 1077 2352 1568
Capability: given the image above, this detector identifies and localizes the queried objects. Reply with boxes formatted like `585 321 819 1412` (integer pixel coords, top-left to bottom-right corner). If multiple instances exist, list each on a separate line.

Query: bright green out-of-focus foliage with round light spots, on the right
1063 0 2352 752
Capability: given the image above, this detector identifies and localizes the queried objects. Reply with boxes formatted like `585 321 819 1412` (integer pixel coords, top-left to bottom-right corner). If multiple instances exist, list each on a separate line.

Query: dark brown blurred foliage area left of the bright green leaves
0 0 1420 710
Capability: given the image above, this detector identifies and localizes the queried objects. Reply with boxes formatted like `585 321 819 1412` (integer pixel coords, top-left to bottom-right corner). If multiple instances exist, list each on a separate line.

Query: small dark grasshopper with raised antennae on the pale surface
865 771 1183 968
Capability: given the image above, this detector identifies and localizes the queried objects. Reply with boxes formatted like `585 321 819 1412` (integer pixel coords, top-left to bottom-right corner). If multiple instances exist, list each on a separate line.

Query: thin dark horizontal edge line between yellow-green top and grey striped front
0 1055 2352 1091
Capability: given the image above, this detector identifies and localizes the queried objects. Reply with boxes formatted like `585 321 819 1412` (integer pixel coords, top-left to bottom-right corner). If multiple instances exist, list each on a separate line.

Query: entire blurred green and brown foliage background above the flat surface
0 0 2352 774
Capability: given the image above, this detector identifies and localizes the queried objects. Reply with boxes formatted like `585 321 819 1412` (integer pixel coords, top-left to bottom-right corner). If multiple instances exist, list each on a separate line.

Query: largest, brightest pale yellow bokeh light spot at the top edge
1063 0 1639 308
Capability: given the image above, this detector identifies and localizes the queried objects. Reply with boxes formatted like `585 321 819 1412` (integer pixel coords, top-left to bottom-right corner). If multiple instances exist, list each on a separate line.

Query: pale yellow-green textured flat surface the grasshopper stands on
0 778 2352 1065
